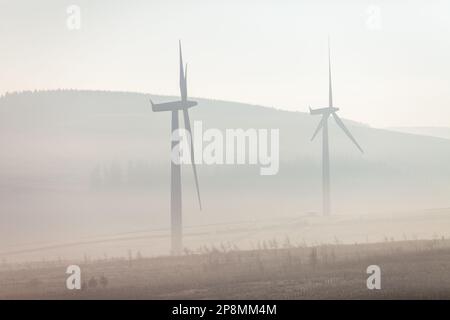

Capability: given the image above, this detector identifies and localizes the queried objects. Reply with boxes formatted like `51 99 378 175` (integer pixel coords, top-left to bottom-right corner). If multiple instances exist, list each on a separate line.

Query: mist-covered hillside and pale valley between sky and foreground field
0 90 450 261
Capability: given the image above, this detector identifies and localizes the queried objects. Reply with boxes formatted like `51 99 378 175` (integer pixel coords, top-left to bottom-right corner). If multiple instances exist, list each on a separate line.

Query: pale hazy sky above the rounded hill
0 0 450 127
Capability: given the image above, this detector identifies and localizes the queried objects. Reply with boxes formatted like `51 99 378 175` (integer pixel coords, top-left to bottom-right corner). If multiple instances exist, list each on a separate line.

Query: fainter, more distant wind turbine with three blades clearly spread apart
309 40 364 216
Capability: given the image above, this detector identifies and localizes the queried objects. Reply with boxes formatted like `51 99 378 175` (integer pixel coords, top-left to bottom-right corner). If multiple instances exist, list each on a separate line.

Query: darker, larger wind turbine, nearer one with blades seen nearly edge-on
150 41 202 255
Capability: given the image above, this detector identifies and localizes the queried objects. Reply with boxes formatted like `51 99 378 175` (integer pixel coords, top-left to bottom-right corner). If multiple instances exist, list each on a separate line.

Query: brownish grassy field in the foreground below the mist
0 237 450 299
